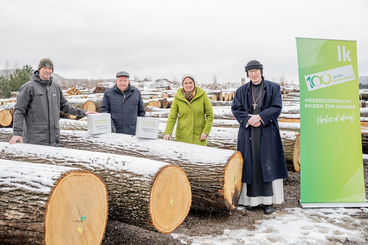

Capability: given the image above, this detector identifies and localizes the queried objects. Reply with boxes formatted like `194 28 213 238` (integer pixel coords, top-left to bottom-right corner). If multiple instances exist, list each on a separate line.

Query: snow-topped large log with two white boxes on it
15 129 243 210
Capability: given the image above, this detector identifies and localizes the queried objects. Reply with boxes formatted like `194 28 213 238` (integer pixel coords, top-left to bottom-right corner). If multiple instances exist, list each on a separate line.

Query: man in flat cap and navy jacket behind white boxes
101 71 146 135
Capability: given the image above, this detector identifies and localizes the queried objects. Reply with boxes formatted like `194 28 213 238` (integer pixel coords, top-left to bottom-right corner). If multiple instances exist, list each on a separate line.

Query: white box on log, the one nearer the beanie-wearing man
87 113 111 135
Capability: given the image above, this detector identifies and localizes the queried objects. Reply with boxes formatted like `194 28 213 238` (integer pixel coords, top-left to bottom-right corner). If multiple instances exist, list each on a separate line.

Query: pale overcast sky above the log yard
0 0 368 82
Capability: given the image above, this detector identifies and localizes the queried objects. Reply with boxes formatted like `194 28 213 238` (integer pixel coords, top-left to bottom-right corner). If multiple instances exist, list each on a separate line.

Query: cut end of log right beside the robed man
223 151 243 210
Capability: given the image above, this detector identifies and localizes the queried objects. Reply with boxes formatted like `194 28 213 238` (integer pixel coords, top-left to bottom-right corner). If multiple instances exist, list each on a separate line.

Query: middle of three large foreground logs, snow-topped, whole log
0 143 191 233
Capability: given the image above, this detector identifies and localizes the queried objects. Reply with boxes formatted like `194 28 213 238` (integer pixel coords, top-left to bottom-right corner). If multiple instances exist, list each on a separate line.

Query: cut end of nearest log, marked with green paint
45 171 108 244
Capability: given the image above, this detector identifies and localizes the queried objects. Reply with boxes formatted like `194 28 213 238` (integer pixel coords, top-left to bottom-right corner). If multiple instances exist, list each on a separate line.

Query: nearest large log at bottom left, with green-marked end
0 160 108 245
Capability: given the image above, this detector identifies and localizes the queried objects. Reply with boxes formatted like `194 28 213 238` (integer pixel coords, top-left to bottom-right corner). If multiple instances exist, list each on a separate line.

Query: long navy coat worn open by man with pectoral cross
231 80 288 183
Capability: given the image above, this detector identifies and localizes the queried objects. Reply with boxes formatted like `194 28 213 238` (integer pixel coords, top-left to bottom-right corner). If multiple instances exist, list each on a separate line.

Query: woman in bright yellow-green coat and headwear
164 76 213 145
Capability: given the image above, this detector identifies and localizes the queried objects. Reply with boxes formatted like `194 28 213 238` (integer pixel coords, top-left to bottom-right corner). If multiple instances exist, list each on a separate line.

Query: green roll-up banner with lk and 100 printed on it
296 38 367 207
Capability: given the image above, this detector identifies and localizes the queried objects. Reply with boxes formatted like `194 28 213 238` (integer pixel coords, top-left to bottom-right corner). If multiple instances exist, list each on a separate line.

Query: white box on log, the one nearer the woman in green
135 117 160 139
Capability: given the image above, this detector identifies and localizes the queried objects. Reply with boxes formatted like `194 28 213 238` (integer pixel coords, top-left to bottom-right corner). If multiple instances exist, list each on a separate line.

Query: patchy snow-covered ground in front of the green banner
171 208 368 245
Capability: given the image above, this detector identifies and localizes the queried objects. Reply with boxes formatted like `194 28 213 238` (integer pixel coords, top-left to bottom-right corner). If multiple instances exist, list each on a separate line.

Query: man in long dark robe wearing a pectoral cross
231 60 288 214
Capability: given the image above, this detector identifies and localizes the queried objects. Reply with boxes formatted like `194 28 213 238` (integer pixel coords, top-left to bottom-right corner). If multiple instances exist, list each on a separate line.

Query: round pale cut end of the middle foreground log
149 165 192 233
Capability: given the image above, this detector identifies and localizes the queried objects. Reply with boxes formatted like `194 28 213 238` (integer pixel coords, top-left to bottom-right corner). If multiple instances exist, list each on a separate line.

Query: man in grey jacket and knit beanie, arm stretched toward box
9 58 95 146
